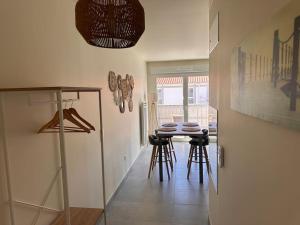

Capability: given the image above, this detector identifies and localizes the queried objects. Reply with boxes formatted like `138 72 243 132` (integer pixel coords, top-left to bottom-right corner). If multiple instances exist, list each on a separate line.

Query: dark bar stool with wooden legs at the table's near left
148 135 173 179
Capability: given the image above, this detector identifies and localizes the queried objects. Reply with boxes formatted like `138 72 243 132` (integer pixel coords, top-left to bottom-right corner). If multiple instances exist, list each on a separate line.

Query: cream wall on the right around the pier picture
209 0 300 225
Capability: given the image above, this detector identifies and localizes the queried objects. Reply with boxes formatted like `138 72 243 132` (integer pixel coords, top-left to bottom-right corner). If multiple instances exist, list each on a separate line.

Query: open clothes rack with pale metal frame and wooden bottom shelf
0 87 106 225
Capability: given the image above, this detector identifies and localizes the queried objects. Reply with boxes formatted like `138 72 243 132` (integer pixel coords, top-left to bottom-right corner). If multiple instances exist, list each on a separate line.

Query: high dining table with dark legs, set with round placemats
155 123 203 184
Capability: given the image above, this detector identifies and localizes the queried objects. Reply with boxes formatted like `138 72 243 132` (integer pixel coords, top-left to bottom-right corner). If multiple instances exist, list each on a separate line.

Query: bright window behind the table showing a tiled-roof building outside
156 76 209 129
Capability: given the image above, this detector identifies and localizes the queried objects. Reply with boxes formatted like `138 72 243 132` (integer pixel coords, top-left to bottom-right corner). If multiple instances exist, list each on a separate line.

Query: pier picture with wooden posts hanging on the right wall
231 0 300 131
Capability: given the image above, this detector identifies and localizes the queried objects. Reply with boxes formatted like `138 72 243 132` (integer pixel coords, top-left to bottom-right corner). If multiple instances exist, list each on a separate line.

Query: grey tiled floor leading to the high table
107 143 208 225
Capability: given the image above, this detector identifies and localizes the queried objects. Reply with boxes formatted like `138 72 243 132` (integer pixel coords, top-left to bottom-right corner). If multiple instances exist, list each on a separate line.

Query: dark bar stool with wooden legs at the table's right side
187 130 209 179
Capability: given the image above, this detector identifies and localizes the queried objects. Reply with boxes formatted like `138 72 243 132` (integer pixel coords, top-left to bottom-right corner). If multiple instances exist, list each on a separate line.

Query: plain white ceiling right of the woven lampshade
135 0 209 61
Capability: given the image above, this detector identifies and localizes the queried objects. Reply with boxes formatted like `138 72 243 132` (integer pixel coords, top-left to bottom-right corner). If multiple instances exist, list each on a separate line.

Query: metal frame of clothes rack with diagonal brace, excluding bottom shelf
0 87 106 225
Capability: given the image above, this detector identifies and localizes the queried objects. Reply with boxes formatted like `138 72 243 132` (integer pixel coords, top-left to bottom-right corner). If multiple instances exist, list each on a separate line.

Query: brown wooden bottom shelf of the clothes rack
51 207 104 225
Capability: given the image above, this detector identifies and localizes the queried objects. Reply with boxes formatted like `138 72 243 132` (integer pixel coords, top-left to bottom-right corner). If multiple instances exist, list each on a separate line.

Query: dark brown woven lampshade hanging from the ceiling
75 0 145 48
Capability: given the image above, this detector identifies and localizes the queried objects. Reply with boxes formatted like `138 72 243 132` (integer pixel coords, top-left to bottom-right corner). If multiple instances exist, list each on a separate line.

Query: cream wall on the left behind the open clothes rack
0 0 147 225
